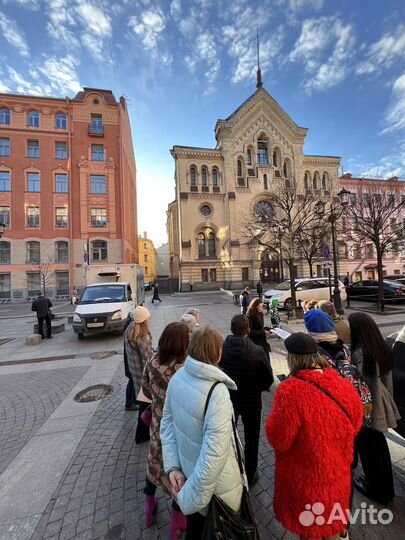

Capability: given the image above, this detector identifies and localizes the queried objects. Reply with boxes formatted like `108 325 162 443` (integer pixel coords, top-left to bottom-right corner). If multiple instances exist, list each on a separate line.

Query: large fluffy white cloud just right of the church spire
289 16 355 92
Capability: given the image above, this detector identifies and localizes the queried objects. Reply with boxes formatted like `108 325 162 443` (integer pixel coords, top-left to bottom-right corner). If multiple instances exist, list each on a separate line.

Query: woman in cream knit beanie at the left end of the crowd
124 306 153 444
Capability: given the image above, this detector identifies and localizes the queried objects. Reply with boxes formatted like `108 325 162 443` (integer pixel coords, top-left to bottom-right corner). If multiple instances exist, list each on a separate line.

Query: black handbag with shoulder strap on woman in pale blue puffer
201 382 260 540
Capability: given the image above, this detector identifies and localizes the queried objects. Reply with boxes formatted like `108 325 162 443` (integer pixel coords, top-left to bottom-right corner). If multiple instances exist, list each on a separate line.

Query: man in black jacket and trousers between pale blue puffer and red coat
220 315 274 485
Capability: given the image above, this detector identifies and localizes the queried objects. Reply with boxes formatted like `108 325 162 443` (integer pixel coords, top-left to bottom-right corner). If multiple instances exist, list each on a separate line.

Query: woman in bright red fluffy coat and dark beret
266 332 363 539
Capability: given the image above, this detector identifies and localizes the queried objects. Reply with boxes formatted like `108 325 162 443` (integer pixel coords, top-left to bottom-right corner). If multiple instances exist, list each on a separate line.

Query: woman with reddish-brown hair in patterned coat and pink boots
142 322 189 540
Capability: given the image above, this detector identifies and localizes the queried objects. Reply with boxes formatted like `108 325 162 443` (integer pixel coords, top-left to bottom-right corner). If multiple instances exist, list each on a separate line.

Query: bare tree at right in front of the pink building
346 182 405 311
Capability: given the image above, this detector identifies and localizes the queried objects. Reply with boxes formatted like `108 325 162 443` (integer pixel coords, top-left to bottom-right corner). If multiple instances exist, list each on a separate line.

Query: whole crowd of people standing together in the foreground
124 291 400 540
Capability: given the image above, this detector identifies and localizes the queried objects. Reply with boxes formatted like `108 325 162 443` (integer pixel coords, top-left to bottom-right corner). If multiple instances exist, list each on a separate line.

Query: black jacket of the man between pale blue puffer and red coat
219 336 274 410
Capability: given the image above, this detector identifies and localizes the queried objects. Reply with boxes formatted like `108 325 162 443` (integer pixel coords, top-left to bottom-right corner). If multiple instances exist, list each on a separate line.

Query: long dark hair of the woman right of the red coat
348 313 393 376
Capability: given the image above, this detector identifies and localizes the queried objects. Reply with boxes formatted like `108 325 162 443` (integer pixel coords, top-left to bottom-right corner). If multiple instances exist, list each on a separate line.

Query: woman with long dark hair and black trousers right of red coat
348 313 400 505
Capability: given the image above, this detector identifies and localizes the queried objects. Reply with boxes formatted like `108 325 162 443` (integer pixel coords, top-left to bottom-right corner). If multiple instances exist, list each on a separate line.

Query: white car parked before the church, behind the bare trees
263 277 346 308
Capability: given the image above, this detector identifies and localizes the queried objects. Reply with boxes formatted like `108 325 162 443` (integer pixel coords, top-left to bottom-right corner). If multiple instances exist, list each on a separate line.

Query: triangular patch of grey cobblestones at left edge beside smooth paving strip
0 367 88 474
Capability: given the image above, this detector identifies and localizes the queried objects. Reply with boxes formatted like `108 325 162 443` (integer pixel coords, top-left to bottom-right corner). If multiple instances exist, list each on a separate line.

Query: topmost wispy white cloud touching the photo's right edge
356 23 405 75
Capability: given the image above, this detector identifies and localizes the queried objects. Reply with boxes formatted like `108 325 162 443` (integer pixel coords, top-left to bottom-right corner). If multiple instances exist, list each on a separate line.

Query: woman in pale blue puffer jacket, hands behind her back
160 326 243 540
